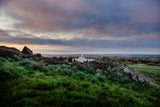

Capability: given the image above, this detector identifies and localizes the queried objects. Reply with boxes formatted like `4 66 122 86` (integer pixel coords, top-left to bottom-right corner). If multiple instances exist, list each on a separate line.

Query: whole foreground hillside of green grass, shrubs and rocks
0 45 160 107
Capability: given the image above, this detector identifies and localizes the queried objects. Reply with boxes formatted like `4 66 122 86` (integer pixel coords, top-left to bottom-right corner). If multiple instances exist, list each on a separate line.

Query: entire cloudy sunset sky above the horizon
0 0 160 54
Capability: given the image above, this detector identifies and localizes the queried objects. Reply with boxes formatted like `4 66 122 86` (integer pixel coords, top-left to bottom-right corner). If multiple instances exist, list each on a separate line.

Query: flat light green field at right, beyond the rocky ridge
128 64 160 84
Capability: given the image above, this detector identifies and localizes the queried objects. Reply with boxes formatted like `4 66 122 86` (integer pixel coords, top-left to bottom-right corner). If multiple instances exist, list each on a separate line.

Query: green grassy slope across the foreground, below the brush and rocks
0 58 160 107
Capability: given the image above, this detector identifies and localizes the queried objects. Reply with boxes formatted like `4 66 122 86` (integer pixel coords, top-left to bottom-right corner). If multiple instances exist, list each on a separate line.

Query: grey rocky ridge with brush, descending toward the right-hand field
71 62 158 86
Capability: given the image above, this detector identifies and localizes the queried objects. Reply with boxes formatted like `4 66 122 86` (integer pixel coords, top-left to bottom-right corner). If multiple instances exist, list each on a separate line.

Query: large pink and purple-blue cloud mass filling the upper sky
0 0 160 34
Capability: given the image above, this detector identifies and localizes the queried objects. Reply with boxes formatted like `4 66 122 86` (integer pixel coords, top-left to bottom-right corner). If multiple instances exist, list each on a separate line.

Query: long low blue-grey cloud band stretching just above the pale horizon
0 30 160 49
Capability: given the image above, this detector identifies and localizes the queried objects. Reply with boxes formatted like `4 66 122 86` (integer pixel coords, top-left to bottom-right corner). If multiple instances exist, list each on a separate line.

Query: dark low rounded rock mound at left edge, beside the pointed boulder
0 46 23 58
